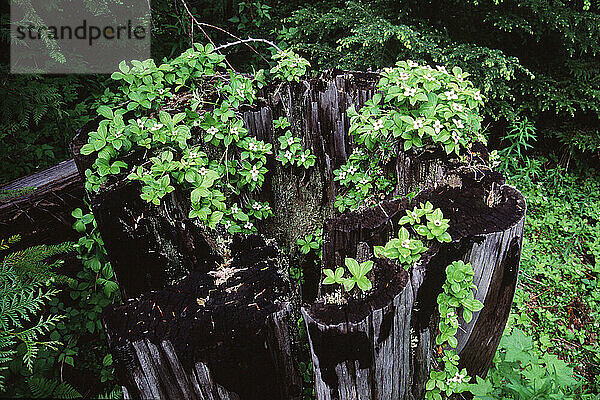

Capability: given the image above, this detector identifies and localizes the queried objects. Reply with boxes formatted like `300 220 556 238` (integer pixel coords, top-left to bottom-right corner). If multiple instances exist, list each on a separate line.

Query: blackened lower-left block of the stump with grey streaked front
103 236 301 399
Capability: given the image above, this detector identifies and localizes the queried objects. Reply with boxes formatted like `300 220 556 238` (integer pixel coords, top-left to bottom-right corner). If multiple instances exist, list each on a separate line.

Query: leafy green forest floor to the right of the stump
476 161 600 399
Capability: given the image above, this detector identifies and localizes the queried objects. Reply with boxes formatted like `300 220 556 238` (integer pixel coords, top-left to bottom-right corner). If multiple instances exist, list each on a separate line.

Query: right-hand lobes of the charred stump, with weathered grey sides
302 172 525 400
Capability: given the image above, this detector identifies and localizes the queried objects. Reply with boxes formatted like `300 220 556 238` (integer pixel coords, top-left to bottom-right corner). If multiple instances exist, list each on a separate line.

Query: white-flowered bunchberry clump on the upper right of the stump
334 61 485 212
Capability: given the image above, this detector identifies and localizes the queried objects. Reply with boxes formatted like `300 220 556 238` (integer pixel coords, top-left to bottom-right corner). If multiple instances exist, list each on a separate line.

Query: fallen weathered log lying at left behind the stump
0 160 83 245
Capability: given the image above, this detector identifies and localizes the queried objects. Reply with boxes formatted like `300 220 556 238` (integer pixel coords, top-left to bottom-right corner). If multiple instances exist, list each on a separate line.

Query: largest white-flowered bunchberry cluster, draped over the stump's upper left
81 44 315 238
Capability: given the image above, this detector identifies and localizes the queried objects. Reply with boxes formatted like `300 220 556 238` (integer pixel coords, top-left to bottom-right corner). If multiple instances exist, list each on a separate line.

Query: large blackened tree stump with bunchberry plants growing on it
73 71 525 400
